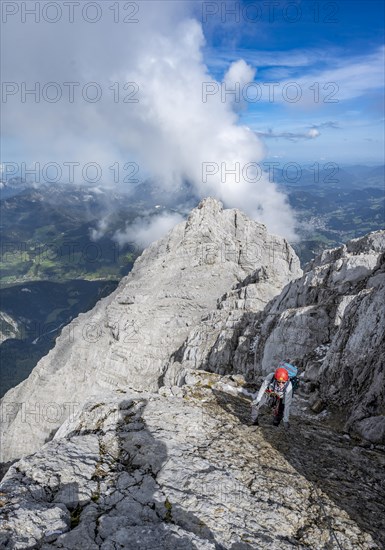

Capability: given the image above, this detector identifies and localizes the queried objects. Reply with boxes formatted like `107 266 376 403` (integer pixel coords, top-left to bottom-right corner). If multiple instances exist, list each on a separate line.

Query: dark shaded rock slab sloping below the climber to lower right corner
213 390 385 548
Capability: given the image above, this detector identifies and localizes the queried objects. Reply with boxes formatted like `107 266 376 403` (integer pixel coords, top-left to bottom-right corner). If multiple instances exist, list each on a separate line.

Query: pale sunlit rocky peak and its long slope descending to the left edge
1 198 301 462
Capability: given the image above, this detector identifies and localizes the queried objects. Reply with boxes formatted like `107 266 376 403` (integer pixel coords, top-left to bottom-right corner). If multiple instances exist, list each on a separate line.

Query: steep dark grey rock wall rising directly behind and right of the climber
250 231 385 444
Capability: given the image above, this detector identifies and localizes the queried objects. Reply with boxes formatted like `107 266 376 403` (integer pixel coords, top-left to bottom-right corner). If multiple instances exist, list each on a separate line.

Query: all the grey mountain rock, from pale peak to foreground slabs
0 199 385 550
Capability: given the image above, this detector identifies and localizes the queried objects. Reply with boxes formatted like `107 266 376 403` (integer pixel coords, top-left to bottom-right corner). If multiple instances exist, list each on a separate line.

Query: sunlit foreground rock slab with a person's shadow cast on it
0 372 380 550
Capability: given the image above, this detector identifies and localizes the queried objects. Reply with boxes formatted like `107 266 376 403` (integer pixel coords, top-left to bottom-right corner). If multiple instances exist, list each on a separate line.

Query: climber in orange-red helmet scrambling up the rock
251 367 293 428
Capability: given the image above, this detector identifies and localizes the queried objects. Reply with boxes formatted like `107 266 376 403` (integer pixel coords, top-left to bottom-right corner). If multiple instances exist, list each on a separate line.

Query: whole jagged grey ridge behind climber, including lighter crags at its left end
179 231 385 445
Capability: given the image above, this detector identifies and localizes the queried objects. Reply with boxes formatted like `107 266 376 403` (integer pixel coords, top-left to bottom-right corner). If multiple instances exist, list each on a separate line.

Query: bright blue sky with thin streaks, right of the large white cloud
201 0 384 163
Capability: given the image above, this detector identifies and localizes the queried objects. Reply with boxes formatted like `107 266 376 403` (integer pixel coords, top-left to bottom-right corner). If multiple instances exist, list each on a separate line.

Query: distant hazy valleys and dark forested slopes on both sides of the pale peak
0 166 385 396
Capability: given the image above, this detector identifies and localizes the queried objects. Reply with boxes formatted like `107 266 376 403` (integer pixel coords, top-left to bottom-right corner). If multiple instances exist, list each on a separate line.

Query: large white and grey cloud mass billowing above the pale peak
3 1 295 239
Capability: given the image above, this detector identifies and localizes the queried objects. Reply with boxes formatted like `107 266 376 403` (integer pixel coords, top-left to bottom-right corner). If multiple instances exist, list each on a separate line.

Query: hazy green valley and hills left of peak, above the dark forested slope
1 182 148 284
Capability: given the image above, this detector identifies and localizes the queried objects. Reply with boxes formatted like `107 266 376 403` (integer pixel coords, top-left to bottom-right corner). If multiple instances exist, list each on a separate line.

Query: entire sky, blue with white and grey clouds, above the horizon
1 0 384 194
